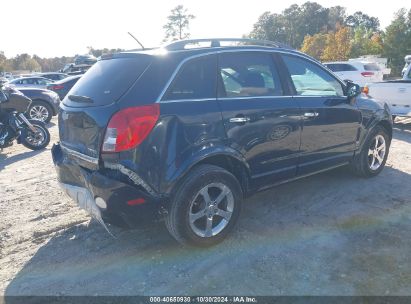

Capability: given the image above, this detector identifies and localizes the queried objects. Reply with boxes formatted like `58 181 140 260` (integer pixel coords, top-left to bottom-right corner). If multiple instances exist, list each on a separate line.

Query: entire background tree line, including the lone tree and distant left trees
0 2 411 76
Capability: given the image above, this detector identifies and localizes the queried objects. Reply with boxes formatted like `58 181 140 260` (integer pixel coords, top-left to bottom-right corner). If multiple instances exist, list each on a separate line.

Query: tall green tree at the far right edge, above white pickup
383 8 411 76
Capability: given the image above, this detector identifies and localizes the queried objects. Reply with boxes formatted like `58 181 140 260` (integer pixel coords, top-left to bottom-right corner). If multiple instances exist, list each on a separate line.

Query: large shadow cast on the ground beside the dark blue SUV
5 163 411 296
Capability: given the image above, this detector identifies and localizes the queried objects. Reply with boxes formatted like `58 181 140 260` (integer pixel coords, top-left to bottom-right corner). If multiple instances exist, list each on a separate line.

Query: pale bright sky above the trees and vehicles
0 0 410 57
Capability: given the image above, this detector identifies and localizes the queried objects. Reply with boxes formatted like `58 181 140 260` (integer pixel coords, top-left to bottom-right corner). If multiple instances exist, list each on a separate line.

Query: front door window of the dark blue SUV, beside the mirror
282 55 344 96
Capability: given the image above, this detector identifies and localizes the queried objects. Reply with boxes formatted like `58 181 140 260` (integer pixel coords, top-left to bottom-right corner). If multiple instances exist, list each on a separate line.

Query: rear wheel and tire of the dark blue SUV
166 165 243 247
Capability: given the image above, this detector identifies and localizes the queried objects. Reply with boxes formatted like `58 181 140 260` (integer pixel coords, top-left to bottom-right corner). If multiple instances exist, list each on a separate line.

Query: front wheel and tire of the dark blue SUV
351 126 391 177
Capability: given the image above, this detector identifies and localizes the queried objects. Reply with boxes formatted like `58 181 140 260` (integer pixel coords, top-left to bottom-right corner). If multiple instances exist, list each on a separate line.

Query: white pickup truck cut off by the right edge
363 64 411 117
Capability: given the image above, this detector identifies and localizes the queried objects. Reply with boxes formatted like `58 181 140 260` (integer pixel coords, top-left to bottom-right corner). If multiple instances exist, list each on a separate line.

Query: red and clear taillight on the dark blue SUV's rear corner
101 103 160 152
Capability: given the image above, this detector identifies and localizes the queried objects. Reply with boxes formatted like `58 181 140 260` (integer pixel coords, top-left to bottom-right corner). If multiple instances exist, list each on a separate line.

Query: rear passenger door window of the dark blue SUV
218 52 283 97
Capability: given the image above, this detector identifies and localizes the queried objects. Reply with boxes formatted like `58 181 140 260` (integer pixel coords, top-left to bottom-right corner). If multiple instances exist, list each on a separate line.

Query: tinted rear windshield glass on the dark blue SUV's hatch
64 55 151 107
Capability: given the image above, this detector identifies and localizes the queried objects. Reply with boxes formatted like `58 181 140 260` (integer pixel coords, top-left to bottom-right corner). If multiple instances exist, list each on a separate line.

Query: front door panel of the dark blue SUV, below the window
295 96 361 175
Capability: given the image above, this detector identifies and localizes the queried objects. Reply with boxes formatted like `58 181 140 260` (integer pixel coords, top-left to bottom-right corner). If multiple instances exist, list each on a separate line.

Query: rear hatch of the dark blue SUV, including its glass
59 54 152 158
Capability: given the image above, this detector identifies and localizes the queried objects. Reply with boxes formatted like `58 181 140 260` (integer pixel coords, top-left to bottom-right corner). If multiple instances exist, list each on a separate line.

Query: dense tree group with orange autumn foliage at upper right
248 2 411 76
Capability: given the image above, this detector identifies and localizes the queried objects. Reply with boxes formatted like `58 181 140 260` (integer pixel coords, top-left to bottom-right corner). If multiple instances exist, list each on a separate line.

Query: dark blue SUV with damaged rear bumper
52 39 392 246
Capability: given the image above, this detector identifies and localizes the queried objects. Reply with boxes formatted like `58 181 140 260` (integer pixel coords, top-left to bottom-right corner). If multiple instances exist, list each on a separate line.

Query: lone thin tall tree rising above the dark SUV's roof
163 5 195 41
